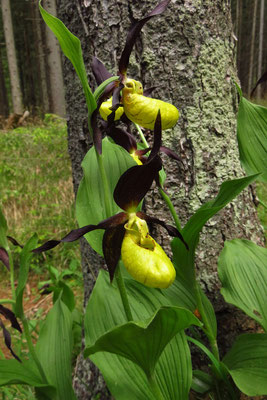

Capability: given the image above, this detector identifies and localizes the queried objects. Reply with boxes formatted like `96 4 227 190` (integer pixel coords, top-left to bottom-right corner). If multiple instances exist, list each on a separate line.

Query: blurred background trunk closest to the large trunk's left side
42 0 66 117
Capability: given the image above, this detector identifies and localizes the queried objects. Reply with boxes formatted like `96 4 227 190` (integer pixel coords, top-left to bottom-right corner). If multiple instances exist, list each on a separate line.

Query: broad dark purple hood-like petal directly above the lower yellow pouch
113 157 162 212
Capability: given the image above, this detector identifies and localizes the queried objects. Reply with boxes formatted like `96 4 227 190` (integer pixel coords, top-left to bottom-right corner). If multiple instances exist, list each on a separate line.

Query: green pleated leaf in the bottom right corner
223 333 267 396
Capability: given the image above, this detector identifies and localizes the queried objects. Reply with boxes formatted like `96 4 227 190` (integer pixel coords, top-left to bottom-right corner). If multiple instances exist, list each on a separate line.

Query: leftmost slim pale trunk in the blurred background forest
1 0 23 114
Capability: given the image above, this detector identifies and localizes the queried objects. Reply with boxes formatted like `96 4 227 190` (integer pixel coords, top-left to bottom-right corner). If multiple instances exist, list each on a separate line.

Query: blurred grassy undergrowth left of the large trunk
0 114 80 273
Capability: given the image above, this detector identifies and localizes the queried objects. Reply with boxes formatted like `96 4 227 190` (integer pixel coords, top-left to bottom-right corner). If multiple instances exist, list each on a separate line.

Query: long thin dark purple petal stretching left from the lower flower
32 212 128 253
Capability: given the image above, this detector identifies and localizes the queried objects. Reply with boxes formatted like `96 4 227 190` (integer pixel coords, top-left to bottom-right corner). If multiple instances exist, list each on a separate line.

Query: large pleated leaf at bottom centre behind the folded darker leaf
85 271 196 400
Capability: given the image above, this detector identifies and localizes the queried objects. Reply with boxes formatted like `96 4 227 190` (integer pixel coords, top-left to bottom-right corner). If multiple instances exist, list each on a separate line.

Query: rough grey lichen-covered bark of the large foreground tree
59 0 262 399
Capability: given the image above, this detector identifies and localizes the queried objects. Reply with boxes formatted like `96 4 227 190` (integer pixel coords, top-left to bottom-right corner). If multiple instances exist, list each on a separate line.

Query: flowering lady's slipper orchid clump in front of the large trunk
0 0 267 400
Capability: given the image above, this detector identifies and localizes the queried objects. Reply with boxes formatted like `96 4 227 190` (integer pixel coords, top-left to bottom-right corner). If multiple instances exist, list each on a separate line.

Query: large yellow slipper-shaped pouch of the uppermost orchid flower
122 79 179 130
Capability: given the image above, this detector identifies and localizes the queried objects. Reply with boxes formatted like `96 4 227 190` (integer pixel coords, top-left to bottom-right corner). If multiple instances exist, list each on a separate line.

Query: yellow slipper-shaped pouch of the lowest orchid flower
121 214 176 289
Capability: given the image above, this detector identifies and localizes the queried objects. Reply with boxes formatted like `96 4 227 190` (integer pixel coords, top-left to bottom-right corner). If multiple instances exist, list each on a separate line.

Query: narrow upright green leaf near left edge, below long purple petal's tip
14 234 38 318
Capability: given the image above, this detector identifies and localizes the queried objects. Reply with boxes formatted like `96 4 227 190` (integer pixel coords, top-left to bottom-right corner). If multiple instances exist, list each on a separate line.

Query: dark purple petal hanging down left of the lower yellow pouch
103 224 125 282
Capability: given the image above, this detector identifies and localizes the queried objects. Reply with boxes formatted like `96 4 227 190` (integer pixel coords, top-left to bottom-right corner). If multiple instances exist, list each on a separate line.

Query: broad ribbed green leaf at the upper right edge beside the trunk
237 86 267 182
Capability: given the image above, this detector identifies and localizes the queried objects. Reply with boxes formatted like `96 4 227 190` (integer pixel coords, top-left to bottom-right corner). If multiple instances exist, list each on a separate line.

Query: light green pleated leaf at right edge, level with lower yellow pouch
218 239 267 331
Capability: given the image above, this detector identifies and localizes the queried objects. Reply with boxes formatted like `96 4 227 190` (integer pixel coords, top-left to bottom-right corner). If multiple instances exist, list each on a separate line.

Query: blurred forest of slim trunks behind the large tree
0 0 267 124
